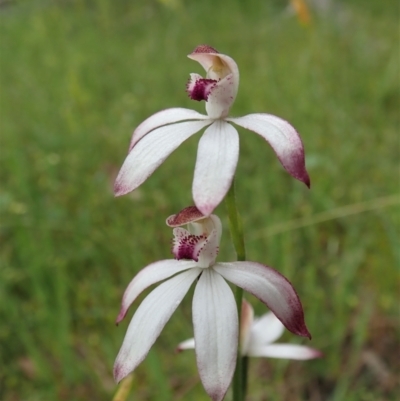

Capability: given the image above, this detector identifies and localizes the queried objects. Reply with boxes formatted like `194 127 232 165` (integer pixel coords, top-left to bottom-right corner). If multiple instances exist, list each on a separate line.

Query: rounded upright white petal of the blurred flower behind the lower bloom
250 312 285 345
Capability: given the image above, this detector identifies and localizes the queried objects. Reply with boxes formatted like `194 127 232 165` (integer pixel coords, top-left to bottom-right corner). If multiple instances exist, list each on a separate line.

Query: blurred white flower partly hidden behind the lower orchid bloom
177 300 322 360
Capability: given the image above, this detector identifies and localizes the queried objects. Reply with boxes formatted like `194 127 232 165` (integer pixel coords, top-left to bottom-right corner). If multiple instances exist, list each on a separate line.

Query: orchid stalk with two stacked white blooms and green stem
115 45 310 401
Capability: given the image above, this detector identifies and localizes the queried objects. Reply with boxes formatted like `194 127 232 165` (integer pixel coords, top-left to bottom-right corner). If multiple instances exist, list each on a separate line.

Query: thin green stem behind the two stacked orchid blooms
225 181 247 401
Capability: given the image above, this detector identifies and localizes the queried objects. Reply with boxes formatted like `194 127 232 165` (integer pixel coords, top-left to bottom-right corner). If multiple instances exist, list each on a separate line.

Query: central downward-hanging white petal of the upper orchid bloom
192 121 239 215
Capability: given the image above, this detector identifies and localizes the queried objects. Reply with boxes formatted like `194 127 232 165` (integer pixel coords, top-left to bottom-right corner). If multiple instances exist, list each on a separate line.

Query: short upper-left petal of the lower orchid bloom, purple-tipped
116 259 196 324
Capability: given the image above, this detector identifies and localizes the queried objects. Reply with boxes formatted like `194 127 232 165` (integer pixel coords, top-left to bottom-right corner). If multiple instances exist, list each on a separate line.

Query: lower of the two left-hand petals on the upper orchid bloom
114 120 210 196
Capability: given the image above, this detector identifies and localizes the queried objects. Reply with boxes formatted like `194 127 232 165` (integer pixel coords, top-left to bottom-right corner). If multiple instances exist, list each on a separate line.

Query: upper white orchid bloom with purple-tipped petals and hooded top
114 45 310 216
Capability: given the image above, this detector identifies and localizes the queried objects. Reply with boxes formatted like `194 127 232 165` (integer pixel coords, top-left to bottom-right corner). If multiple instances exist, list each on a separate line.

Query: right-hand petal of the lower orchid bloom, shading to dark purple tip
213 262 311 338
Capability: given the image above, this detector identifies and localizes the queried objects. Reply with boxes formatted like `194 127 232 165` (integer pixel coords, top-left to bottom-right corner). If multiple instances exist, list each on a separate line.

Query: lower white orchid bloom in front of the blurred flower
114 206 310 401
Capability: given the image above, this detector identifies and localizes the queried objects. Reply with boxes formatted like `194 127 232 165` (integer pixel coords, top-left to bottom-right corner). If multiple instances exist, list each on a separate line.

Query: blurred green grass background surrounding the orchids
0 0 400 401
